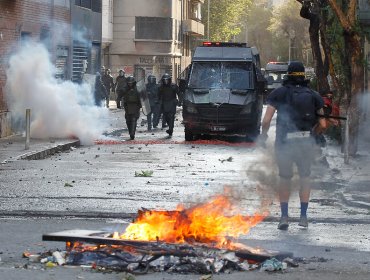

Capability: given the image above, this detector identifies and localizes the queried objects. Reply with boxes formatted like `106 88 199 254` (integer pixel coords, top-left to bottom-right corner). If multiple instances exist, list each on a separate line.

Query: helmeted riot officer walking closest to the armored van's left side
158 73 180 137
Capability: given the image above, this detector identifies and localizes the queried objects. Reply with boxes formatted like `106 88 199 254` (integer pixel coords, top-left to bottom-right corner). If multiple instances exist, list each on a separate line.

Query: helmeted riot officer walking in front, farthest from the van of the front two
123 76 141 140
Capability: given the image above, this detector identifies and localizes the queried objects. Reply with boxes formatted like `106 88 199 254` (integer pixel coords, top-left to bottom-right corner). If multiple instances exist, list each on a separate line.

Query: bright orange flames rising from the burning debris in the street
119 191 267 248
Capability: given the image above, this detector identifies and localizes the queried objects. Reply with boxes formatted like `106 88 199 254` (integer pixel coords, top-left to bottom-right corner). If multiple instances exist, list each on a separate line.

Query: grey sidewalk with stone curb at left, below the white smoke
0 135 80 164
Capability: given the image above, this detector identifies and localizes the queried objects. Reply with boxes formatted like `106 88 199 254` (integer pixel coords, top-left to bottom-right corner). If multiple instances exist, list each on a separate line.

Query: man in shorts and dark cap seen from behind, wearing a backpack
260 61 326 230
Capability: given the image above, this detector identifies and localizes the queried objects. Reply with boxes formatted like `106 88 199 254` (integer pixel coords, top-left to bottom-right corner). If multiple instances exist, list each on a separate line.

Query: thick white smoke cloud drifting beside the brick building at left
6 43 108 145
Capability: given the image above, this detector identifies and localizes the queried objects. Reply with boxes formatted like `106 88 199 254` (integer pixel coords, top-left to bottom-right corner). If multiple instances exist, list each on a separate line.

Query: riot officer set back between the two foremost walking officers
146 75 160 130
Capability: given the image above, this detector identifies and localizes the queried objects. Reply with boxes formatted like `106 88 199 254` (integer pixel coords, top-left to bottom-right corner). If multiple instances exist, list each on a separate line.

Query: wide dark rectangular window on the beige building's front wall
135 17 172 40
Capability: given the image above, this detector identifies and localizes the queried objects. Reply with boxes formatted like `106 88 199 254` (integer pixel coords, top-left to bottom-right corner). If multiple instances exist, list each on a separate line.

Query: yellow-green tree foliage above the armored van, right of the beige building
203 0 252 42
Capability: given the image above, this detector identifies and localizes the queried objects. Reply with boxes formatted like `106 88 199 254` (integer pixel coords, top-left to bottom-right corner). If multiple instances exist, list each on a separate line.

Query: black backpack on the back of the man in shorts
286 86 317 131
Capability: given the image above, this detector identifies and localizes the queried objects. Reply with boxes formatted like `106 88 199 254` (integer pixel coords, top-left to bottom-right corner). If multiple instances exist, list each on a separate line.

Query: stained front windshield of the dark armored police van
189 61 254 89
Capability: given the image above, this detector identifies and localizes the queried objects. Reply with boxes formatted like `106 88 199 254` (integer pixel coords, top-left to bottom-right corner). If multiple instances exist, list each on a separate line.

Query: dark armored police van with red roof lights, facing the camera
180 42 266 141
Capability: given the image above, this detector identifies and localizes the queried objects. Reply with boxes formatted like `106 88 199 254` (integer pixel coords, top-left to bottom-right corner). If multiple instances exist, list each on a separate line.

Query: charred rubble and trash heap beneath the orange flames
23 243 302 280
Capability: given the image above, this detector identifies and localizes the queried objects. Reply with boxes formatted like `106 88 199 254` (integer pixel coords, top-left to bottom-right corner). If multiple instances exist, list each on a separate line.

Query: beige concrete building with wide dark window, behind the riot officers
103 0 204 81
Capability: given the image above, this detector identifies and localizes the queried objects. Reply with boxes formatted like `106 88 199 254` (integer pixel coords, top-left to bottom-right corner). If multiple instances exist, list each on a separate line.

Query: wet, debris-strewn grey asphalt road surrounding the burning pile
0 106 370 279
